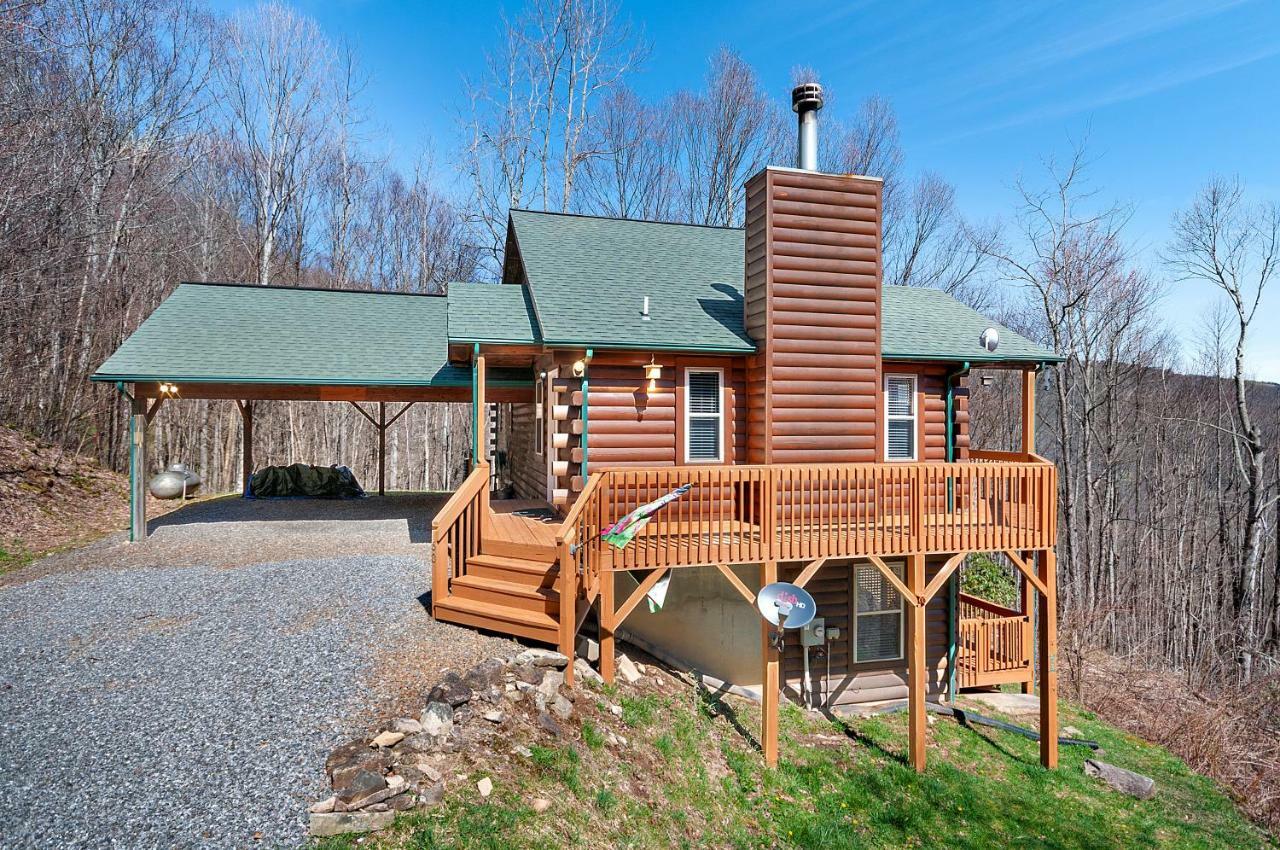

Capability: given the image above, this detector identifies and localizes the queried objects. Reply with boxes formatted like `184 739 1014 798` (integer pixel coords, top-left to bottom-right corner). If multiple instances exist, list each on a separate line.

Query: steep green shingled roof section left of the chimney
511 210 755 352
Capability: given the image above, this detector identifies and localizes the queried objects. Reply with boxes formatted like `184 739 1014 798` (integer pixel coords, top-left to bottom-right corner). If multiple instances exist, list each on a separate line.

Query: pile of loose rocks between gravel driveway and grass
310 649 573 836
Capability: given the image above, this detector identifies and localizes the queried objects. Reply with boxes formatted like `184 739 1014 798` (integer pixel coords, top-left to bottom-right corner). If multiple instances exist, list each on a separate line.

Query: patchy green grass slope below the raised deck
317 690 1276 850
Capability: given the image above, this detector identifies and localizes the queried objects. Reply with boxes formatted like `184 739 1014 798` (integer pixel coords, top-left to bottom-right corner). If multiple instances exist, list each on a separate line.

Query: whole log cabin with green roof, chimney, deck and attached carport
93 84 1060 769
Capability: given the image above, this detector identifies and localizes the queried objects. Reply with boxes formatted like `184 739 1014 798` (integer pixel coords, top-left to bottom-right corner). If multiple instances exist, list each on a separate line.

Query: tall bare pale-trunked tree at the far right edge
1167 177 1280 681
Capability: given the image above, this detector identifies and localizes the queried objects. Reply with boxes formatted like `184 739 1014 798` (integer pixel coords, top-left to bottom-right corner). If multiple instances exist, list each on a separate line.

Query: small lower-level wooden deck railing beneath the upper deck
956 594 1034 687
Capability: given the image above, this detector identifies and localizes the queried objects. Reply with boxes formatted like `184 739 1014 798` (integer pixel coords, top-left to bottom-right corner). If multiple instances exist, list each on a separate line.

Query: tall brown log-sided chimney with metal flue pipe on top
744 83 883 463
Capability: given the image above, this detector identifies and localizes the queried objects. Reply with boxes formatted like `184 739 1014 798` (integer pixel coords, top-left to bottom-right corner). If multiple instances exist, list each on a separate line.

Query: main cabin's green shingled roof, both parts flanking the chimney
509 210 1061 362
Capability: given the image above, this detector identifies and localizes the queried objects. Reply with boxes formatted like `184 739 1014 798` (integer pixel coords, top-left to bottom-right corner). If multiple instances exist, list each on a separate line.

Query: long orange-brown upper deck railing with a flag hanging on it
572 453 1057 571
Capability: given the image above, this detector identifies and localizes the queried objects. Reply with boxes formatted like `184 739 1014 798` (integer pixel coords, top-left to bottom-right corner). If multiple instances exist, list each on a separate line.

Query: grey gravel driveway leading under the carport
0 497 513 847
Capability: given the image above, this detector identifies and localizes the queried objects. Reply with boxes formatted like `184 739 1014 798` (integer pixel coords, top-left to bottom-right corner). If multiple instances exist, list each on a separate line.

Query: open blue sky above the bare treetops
227 0 1280 381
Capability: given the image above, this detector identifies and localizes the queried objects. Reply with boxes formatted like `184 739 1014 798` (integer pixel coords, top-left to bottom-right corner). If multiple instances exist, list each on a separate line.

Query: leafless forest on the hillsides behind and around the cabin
0 0 1280 805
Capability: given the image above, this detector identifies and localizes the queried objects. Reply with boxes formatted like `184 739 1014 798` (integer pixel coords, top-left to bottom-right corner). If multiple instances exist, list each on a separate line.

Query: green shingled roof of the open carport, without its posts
93 283 530 387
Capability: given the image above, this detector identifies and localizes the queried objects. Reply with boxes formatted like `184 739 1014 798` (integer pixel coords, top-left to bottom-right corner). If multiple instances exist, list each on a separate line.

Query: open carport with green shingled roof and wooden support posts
92 283 534 540
